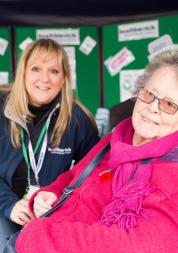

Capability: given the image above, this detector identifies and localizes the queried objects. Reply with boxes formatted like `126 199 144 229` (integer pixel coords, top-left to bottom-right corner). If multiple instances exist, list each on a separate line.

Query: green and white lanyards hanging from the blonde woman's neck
20 104 59 187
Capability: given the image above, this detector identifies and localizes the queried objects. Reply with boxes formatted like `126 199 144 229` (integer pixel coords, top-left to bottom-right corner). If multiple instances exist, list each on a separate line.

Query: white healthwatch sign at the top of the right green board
118 20 159 41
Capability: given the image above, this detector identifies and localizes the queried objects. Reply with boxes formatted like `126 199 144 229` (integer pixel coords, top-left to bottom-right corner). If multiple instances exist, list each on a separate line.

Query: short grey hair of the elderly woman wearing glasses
135 49 178 93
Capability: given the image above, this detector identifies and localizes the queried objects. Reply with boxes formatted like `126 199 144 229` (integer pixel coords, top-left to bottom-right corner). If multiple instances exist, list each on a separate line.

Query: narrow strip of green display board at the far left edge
0 27 12 85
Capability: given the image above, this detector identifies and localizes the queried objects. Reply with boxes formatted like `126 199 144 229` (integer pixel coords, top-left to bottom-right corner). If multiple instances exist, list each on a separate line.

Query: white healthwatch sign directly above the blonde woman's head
36 28 80 45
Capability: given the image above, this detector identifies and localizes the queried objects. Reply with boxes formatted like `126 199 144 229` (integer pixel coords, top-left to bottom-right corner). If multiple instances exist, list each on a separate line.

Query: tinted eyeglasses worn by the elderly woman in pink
137 88 178 115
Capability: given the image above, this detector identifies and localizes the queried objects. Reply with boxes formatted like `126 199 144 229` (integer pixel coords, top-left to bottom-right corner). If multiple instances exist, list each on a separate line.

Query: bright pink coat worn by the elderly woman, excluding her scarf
16 136 178 253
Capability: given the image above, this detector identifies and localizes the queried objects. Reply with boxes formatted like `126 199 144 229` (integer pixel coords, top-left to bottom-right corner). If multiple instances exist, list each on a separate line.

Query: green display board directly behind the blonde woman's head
15 26 100 114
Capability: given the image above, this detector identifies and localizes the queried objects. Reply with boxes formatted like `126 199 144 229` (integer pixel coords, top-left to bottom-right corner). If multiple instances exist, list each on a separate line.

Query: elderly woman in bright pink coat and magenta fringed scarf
16 51 178 253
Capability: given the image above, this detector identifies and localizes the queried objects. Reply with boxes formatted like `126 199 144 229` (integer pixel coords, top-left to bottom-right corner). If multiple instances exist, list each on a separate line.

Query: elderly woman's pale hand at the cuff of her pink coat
33 191 57 217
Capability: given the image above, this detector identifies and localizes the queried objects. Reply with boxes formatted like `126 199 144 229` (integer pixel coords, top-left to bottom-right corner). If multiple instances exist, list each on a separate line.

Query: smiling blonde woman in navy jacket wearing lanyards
0 39 98 248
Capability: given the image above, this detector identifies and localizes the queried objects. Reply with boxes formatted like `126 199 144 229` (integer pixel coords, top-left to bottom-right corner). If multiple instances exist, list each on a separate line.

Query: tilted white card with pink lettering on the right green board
105 47 135 76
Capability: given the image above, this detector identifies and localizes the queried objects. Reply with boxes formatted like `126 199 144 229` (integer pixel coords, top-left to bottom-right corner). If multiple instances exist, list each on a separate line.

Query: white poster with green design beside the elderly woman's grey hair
120 69 144 102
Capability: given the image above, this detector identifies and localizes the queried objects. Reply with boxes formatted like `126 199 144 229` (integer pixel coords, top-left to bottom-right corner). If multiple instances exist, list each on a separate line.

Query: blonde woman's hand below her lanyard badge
10 199 35 226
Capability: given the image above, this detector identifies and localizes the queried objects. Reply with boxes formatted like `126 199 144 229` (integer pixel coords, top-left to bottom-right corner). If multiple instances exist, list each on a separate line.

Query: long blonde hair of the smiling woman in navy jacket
7 39 97 147
